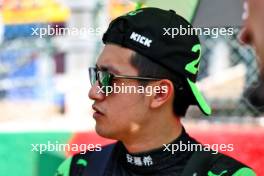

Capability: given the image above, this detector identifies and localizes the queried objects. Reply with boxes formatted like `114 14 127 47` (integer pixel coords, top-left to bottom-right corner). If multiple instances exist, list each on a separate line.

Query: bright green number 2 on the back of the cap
185 44 201 75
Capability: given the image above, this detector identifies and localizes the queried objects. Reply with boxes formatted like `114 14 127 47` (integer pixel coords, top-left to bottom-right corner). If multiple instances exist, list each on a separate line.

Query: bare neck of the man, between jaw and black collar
122 115 183 153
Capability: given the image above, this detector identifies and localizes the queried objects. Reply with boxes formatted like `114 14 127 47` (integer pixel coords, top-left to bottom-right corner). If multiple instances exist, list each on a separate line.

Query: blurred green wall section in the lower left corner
0 132 71 176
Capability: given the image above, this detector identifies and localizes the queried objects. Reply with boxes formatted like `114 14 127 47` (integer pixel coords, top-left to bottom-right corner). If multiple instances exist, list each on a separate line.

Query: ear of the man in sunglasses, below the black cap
150 79 174 108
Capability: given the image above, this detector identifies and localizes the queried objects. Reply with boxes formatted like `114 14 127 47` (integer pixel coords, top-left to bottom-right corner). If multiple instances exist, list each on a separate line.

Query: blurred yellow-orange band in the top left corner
2 0 70 24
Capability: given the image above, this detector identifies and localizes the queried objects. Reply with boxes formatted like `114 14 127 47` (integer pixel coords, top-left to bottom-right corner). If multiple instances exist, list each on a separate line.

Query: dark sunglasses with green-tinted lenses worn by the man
89 67 161 91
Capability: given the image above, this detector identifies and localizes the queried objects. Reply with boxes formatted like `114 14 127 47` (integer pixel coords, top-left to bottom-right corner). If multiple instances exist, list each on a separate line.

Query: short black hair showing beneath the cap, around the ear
131 52 191 117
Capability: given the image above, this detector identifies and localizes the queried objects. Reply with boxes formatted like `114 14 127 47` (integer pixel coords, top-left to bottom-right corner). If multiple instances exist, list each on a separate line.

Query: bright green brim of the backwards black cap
187 78 212 116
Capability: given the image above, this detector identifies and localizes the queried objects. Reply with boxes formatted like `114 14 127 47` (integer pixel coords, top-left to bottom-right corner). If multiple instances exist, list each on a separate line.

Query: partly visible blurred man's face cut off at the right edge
240 0 264 112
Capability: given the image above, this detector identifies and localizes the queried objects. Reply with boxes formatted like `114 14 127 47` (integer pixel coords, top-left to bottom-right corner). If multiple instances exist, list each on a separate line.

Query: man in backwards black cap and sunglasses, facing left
57 8 255 176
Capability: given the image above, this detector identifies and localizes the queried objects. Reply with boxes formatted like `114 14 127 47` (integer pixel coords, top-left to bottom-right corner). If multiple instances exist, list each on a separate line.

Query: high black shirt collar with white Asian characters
117 128 197 174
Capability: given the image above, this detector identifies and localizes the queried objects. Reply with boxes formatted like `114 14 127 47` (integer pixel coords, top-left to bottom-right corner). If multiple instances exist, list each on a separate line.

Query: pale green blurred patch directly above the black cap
145 0 199 22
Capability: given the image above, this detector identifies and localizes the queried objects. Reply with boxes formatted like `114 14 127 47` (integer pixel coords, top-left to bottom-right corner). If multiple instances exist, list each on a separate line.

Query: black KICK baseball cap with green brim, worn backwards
103 7 211 115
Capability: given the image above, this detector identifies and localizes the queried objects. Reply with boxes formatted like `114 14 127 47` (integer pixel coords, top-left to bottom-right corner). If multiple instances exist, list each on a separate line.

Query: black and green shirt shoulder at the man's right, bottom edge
208 154 256 176
